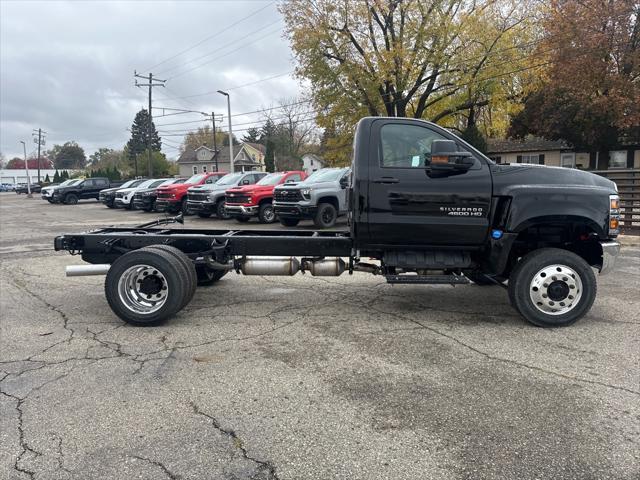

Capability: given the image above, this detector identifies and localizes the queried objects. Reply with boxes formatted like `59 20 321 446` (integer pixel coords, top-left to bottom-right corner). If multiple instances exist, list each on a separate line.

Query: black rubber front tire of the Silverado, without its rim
508 248 598 327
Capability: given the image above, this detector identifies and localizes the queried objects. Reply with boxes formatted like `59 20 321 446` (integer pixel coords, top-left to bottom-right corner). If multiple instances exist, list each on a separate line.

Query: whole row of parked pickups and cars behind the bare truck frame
42 168 349 228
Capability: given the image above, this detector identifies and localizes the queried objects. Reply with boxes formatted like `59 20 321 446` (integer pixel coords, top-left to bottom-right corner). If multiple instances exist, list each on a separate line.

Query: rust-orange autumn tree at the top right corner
509 0 640 155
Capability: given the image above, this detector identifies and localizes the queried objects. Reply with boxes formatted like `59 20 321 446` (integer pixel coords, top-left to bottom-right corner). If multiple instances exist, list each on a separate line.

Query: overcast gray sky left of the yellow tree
0 0 301 159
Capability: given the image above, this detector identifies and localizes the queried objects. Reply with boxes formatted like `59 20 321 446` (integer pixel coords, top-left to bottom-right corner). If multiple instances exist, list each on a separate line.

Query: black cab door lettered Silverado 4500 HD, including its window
368 119 492 246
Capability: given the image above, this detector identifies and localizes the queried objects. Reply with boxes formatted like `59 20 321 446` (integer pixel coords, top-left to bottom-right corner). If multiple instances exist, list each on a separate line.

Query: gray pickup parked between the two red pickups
187 172 266 220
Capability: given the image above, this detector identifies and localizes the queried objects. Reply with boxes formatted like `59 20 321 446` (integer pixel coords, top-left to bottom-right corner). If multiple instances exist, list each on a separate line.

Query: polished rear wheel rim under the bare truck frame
118 265 169 314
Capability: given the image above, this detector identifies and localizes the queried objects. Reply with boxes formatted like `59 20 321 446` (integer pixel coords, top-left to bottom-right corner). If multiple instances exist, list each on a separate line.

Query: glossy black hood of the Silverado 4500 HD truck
491 163 616 195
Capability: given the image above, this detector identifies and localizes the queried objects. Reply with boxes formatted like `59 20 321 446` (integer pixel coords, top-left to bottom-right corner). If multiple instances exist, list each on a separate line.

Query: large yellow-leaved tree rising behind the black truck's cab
280 0 537 162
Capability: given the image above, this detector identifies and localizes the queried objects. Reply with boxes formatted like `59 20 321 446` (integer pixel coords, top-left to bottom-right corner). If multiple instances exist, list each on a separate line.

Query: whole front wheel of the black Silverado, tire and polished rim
509 248 597 327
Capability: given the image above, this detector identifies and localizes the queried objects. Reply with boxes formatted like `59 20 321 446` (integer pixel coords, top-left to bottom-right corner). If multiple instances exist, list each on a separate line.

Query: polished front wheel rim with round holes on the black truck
529 265 582 315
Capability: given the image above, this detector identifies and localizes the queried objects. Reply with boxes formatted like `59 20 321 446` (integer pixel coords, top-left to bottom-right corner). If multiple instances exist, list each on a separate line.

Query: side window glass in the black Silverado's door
380 124 446 168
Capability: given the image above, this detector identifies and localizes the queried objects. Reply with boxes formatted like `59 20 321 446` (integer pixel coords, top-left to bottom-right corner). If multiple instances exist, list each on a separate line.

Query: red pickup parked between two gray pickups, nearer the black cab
225 170 307 223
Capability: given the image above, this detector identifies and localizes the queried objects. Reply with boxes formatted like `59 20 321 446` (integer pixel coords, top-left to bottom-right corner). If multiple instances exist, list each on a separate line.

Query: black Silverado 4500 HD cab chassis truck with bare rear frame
55 117 620 327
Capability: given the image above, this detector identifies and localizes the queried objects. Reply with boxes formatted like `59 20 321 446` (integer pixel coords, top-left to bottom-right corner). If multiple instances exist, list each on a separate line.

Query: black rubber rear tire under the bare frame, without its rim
104 248 188 326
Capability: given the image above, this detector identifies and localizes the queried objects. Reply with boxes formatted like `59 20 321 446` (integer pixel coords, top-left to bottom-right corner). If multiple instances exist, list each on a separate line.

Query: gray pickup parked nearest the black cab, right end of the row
273 168 350 228
